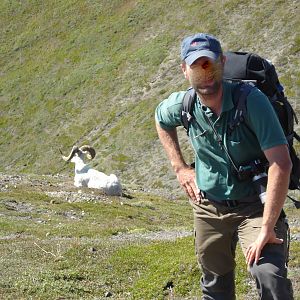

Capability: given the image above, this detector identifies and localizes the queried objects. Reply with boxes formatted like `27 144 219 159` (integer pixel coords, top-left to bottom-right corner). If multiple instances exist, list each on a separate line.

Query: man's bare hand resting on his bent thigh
246 226 283 266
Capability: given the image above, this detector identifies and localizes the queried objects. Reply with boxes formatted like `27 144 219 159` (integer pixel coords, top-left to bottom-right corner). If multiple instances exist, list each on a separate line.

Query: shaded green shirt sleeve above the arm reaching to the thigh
247 88 287 151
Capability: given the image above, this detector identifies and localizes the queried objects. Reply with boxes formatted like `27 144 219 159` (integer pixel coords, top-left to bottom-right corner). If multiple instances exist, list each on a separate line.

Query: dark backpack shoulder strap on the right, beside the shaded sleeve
228 82 253 134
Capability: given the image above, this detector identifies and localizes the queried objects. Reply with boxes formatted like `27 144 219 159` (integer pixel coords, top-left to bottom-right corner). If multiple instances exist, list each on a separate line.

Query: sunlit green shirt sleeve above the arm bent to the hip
155 91 185 129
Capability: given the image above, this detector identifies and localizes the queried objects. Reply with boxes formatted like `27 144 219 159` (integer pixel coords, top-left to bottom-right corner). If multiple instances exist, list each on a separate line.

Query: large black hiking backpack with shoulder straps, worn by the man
181 52 300 208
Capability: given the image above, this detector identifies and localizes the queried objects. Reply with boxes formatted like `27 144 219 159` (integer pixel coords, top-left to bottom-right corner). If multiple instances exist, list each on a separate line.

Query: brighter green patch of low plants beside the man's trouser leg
105 238 200 299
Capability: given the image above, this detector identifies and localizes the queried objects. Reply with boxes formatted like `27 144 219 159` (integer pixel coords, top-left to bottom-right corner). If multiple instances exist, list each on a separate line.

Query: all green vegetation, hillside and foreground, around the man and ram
0 0 300 299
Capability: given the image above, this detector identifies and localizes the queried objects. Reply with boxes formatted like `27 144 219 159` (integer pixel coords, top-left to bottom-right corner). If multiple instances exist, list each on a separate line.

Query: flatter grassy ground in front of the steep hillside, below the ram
0 176 300 300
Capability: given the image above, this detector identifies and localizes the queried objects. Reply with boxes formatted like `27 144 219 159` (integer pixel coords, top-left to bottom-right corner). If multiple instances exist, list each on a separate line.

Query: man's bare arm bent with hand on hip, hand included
156 122 201 203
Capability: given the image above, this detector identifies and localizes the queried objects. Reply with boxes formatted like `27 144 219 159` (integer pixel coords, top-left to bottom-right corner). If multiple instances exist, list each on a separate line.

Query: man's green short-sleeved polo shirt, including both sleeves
155 82 287 200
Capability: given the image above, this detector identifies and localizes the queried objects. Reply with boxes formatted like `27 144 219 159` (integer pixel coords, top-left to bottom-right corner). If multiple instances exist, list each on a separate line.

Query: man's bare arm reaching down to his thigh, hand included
246 145 292 265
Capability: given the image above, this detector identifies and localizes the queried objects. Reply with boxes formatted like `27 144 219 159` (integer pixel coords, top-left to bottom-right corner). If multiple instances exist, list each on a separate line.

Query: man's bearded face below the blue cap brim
182 56 224 95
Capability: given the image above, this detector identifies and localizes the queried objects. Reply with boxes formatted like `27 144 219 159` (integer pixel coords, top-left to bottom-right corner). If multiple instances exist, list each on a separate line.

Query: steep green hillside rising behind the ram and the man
0 0 300 192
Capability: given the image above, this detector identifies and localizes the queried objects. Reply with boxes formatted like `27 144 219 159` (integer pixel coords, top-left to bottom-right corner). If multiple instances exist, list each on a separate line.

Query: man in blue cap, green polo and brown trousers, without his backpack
155 33 293 300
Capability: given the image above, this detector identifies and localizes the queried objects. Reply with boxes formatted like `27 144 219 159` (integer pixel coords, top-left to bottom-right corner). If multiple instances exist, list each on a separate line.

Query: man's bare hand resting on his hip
176 166 202 204
